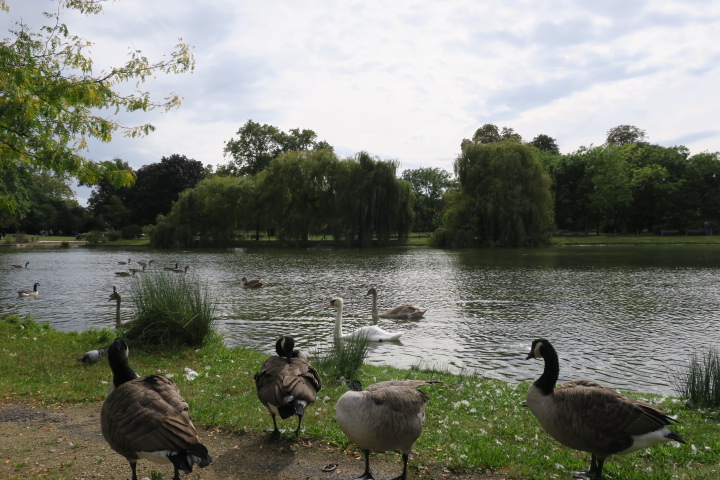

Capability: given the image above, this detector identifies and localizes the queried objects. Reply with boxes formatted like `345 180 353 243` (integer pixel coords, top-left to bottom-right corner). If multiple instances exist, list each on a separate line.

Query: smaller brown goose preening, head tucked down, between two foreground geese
254 337 322 435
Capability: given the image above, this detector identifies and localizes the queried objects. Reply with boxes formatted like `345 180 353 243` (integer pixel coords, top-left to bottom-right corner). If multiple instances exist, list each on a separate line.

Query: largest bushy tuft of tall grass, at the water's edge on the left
121 272 217 348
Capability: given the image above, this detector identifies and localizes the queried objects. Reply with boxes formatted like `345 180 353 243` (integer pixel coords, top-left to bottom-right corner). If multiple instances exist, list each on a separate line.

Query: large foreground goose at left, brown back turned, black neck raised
100 338 212 480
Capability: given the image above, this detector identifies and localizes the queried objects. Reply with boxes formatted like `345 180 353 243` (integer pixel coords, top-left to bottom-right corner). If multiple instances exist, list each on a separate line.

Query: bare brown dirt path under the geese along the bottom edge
0 400 507 480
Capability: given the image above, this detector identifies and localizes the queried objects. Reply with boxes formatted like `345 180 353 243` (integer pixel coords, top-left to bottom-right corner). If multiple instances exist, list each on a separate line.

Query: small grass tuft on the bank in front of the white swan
311 337 370 381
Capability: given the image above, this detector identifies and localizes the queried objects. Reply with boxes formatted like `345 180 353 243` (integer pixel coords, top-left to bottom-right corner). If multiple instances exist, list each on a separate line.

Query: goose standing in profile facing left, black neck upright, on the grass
527 339 685 479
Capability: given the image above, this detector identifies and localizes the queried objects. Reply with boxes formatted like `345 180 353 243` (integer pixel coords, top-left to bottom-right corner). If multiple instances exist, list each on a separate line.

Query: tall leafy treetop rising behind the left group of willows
221 120 332 175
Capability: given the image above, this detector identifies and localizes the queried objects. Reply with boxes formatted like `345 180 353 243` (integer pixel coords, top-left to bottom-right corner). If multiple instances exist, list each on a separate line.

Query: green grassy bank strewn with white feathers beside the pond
0 317 720 480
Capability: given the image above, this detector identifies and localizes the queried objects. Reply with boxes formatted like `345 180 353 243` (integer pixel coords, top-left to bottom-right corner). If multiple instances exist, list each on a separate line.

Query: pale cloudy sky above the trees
0 0 720 203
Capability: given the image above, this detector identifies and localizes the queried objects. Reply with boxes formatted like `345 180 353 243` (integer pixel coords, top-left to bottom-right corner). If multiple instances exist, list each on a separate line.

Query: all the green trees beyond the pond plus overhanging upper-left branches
0 0 720 247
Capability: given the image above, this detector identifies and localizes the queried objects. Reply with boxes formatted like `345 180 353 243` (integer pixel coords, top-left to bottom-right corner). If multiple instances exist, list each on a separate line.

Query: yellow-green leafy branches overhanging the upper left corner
0 0 194 202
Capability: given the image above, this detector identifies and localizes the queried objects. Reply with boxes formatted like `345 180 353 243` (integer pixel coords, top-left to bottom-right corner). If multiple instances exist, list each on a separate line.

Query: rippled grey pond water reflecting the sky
0 245 720 394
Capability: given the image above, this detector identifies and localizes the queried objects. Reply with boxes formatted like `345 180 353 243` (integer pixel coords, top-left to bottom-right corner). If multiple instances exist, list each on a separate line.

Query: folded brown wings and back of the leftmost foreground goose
101 375 198 458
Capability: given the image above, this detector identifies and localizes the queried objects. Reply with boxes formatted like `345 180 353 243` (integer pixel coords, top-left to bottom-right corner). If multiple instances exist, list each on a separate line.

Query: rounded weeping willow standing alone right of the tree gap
434 141 553 247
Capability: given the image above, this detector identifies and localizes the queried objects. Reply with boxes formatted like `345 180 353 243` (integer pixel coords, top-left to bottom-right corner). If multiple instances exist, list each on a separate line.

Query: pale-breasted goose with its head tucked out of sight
335 380 441 480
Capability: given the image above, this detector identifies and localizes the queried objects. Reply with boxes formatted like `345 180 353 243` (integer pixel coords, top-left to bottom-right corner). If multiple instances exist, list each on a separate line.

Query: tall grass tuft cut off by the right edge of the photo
673 347 720 408
